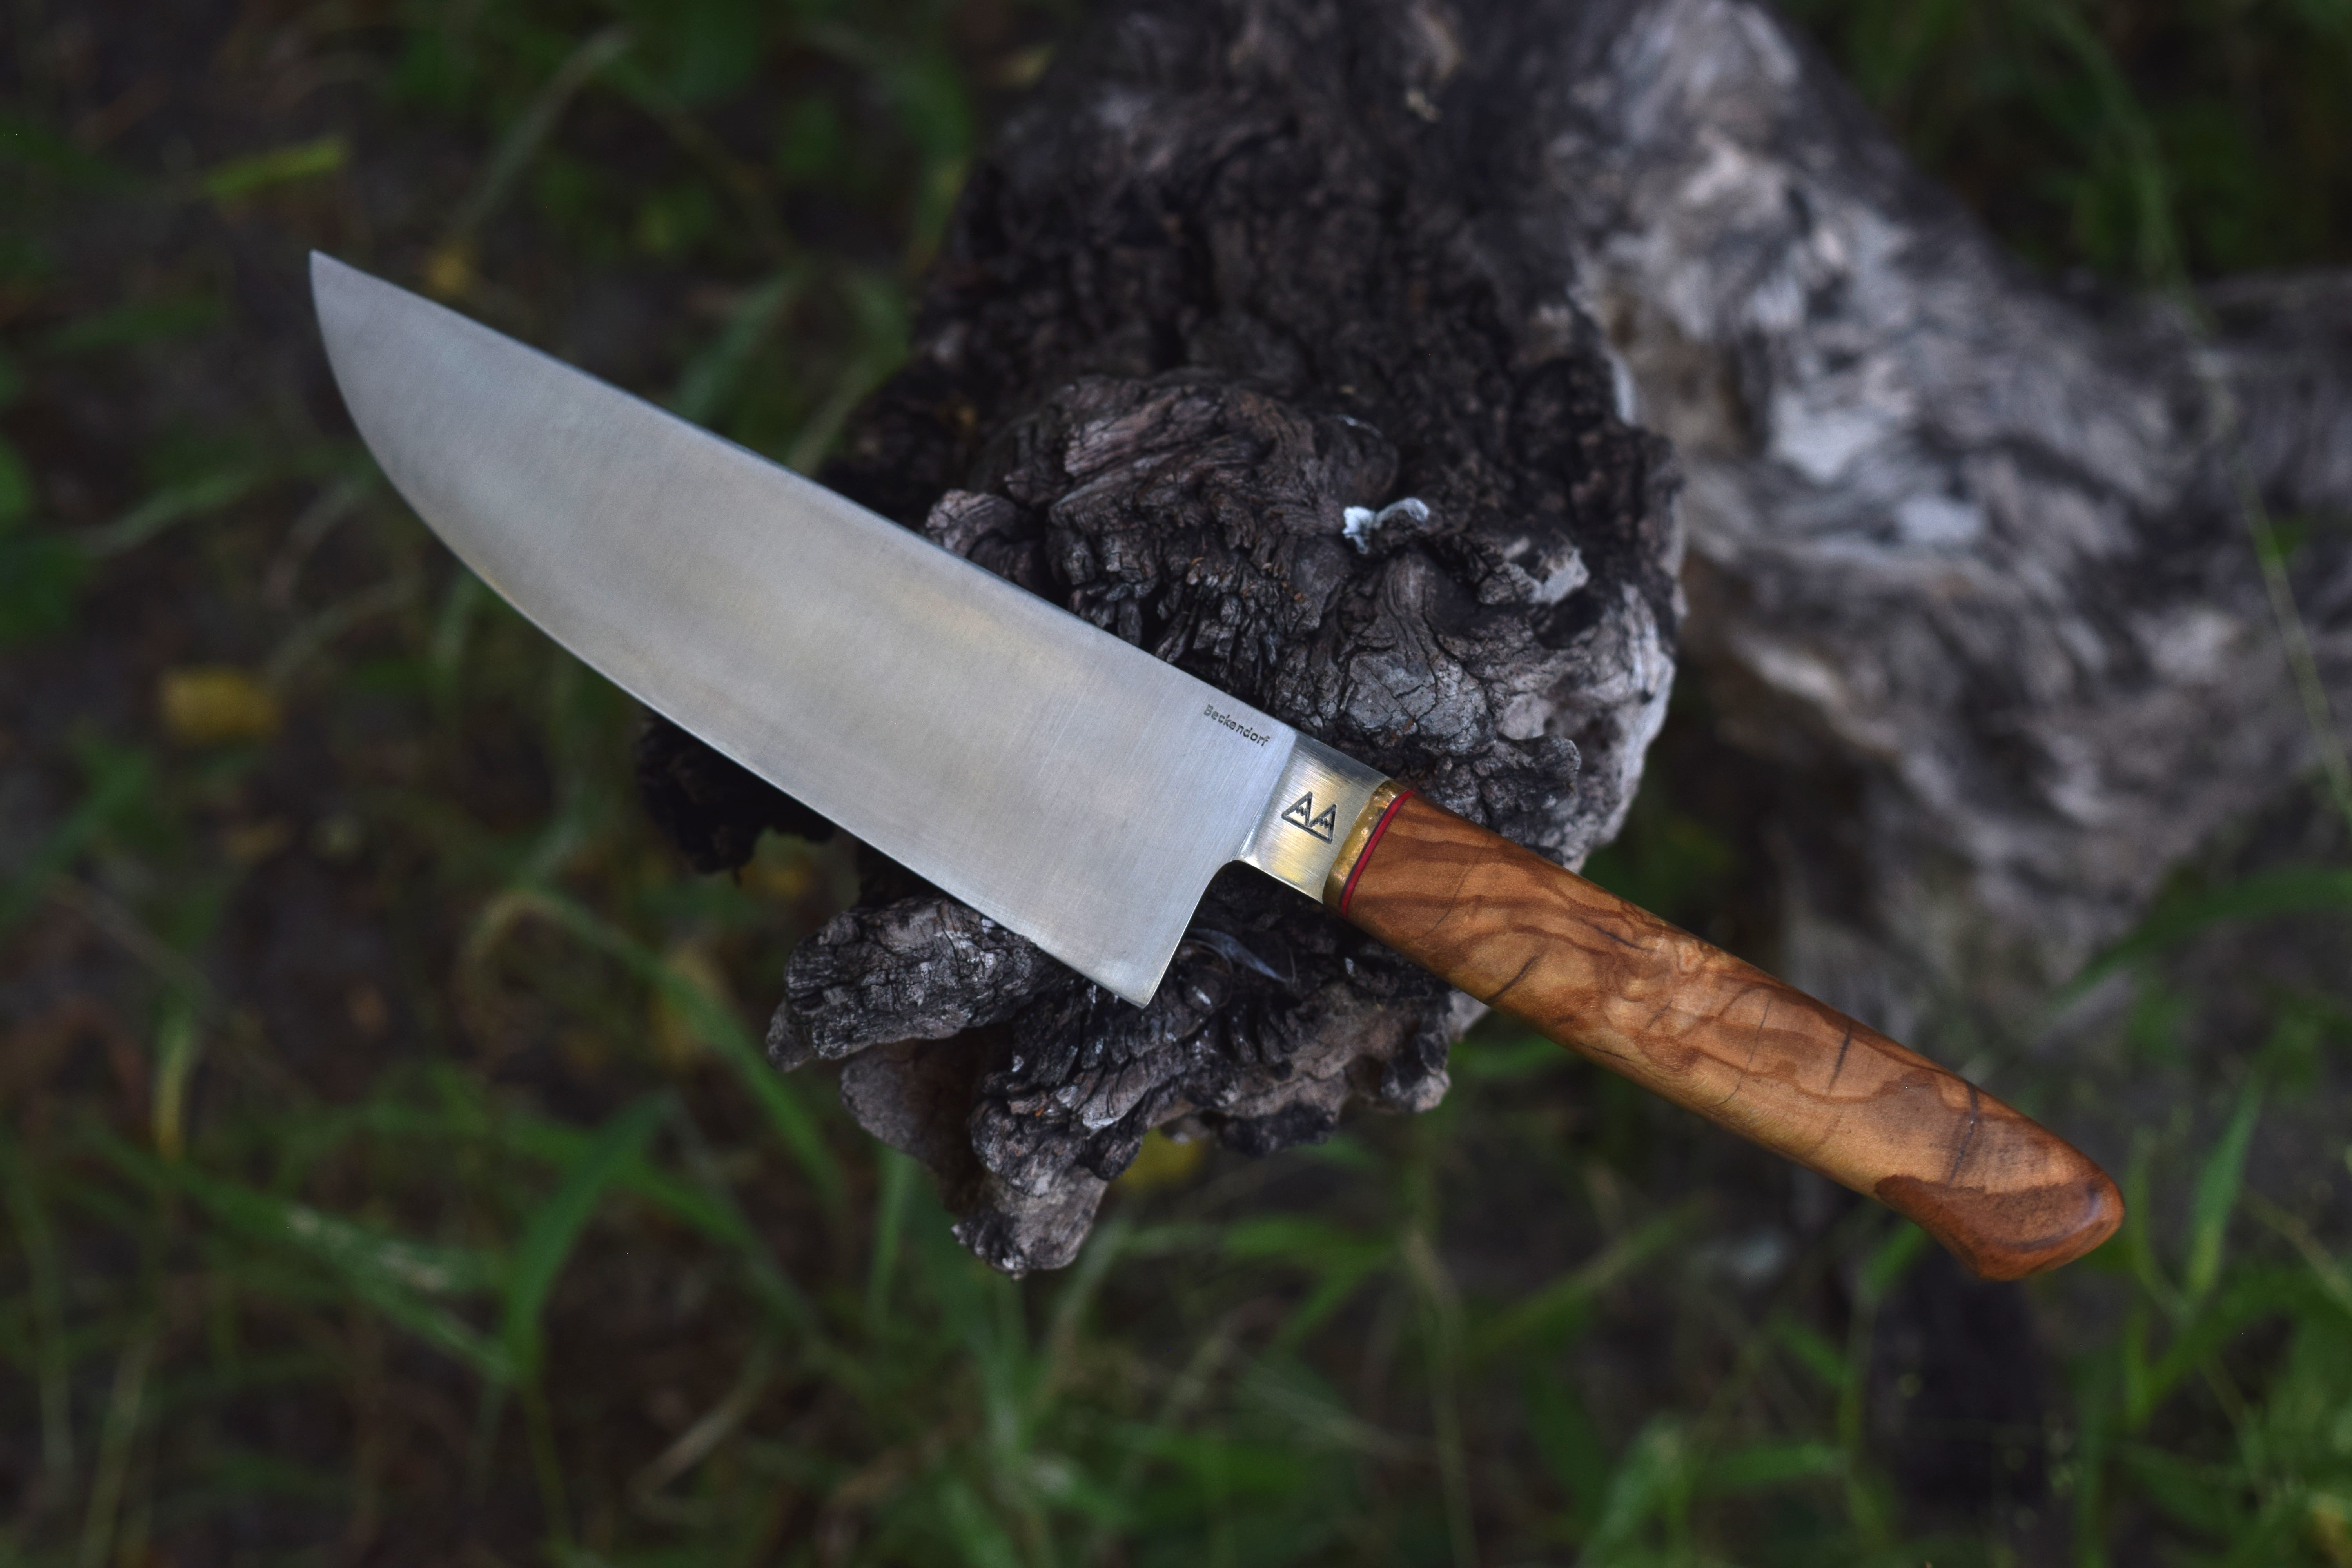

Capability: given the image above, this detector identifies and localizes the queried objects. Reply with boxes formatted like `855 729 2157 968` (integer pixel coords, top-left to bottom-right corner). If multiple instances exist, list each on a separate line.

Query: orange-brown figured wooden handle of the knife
1324 785 2124 1279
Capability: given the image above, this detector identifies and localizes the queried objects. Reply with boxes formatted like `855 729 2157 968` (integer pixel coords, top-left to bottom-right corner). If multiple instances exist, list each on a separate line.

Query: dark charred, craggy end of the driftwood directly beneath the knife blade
635 5 1682 1272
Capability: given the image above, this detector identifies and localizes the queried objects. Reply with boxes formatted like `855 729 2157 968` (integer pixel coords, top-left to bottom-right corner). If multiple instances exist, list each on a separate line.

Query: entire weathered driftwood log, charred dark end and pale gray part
640 0 2352 1272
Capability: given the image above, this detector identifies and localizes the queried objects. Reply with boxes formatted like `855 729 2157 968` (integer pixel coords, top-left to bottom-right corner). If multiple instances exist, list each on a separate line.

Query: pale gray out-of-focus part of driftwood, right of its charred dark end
1536 0 2352 1053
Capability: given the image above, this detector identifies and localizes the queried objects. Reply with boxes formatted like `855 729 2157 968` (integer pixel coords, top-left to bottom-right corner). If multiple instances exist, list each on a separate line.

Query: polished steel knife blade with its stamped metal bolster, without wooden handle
310 256 1381 1004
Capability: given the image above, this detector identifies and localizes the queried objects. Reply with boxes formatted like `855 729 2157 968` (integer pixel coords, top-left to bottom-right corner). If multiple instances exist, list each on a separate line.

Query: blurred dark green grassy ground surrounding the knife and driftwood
0 0 2352 1568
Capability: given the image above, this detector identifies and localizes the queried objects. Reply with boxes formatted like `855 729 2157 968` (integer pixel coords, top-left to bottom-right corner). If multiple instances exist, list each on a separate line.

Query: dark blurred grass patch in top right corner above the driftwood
1788 0 2352 285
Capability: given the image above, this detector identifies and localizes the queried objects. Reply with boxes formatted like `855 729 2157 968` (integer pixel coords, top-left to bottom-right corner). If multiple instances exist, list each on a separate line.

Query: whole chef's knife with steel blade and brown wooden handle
310 256 2124 1279
